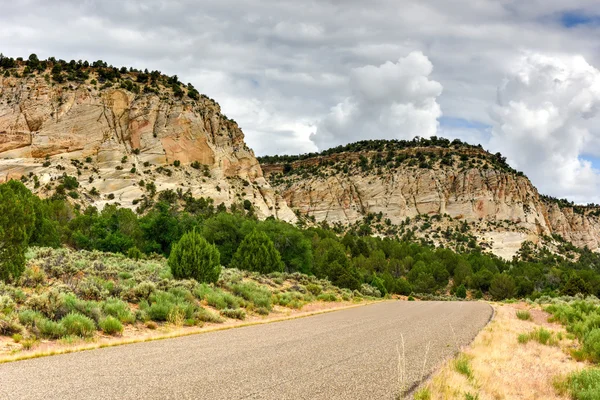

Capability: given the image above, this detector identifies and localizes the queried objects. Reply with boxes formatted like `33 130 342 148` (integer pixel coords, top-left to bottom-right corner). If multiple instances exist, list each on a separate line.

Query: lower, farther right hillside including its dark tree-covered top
260 138 600 258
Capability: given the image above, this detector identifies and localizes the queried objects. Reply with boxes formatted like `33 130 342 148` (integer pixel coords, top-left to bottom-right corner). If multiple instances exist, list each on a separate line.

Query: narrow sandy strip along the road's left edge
0 299 384 364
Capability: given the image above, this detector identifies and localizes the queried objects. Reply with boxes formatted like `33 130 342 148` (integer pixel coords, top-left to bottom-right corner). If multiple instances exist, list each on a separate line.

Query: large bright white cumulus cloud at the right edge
490 53 600 202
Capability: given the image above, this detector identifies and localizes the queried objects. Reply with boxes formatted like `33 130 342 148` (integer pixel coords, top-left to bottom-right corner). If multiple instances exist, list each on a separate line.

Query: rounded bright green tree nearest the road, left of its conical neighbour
169 231 221 283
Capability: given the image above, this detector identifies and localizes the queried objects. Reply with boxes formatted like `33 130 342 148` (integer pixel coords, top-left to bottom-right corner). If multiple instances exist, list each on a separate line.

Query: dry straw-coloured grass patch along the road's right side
418 305 585 400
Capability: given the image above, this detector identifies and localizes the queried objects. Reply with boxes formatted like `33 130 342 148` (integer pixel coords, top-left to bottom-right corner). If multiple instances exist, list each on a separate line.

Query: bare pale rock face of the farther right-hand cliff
263 149 600 258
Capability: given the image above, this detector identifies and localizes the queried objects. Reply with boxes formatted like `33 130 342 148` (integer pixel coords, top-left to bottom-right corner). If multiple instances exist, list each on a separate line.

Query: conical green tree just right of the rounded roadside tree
231 230 284 274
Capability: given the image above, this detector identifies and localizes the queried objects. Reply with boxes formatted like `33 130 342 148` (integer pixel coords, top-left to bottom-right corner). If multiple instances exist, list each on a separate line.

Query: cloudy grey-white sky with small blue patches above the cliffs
0 0 600 203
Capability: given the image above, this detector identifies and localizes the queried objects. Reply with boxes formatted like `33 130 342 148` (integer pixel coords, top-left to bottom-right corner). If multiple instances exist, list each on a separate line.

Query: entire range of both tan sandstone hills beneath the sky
0 55 600 259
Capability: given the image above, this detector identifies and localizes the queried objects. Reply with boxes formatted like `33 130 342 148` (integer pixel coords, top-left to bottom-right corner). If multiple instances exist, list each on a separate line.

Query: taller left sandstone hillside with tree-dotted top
0 55 295 221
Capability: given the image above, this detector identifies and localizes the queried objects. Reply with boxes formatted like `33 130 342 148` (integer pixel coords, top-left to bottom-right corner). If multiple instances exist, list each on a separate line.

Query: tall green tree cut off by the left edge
0 181 35 281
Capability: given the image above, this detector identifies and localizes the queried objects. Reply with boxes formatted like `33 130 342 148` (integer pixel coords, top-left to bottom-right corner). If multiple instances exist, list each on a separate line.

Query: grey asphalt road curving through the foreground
0 301 492 400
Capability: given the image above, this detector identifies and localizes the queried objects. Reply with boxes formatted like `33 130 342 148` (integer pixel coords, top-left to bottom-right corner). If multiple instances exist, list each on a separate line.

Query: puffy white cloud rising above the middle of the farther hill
310 51 442 149
